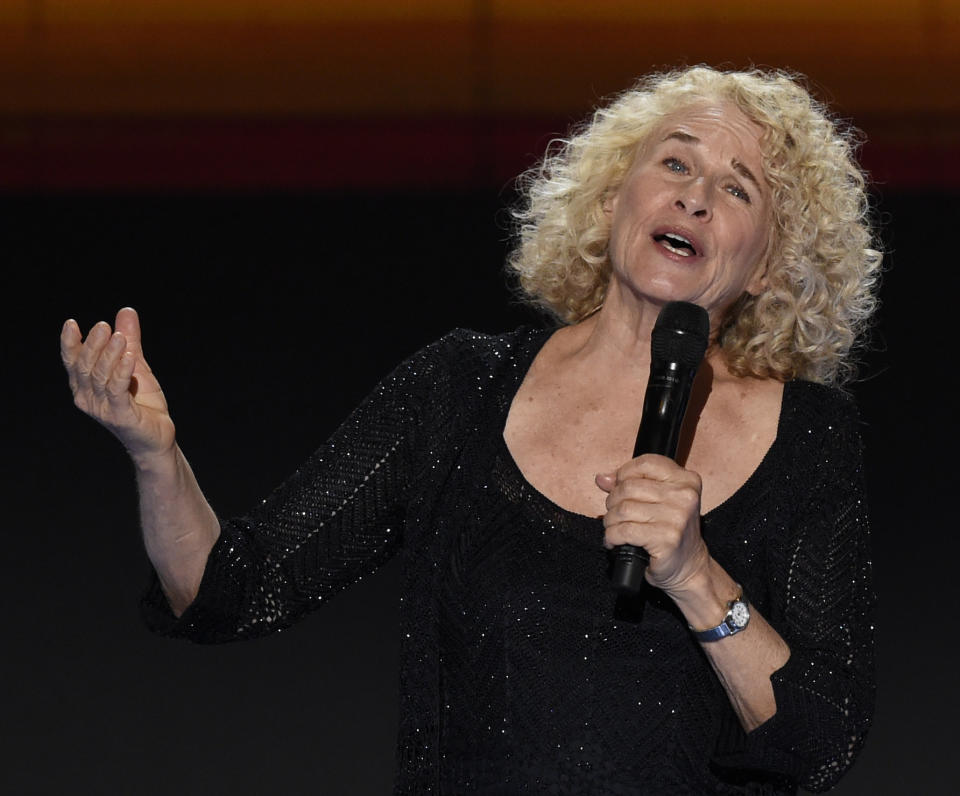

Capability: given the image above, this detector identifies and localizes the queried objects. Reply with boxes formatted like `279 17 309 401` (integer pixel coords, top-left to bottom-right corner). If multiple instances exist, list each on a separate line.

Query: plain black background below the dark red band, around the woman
0 185 960 796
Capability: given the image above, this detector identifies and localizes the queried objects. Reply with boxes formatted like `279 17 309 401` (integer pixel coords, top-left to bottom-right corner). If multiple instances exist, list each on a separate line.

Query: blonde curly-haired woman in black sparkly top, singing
61 68 879 794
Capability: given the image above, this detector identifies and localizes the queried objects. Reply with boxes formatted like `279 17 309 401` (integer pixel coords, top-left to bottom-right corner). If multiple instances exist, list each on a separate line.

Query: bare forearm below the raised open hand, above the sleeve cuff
134 445 220 616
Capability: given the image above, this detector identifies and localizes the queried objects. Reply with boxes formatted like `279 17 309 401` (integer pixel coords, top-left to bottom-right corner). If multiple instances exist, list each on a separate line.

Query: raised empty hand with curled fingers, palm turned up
60 307 175 462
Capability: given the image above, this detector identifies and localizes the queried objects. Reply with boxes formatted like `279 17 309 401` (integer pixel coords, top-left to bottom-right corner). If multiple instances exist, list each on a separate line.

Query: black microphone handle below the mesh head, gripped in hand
611 362 697 594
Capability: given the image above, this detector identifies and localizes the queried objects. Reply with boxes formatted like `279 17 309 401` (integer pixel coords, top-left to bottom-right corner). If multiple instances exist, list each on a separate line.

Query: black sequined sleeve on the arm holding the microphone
723 385 875 792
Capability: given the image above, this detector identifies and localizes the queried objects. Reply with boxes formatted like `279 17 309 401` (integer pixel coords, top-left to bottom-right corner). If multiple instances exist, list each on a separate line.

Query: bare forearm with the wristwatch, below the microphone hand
671 558 790 732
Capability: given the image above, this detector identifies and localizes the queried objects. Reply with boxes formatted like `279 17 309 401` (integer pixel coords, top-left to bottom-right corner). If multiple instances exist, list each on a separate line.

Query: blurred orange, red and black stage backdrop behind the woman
0 0 960 796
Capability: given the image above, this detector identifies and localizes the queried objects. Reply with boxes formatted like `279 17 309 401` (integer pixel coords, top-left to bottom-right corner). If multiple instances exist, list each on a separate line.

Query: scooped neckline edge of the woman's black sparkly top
497 329 795 522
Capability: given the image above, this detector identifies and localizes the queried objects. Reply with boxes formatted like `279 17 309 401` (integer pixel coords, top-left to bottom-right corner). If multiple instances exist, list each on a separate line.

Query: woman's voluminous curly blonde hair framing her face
507 66 881 384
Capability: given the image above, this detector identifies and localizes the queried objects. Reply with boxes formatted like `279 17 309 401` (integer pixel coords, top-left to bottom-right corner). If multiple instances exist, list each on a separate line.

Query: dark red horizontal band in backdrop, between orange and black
0 117 960 193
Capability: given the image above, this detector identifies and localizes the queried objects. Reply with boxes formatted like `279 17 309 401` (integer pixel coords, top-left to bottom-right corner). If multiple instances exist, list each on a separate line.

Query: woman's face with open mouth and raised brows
604 103 771 322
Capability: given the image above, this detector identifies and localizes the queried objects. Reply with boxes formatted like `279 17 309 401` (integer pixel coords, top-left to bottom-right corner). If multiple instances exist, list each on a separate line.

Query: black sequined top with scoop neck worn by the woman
143 329 874 796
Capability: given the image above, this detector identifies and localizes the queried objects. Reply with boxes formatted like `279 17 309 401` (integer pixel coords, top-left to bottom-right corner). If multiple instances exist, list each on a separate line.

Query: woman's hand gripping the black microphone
596 453 710 594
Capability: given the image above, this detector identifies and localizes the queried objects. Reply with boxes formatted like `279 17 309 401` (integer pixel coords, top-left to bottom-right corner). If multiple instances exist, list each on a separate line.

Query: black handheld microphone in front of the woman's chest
612 301 710 595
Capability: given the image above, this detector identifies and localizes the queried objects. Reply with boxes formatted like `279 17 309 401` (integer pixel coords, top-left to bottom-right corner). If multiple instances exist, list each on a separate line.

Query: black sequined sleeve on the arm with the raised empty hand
142 334 443 643
